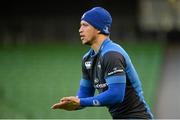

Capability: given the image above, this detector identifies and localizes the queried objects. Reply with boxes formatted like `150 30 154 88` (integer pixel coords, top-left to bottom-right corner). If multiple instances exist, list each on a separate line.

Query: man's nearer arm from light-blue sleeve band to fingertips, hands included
52 76 125 111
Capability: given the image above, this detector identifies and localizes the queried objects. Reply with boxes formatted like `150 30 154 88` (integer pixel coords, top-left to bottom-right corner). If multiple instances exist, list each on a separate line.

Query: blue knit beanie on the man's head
81 7 112 35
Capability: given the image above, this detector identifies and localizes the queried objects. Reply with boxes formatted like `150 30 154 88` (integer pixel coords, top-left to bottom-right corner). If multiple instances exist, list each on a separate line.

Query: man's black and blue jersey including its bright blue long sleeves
77 39 152 118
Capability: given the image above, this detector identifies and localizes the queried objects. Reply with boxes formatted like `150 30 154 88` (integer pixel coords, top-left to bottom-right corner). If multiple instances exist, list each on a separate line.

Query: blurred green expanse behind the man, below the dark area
0 43 163 119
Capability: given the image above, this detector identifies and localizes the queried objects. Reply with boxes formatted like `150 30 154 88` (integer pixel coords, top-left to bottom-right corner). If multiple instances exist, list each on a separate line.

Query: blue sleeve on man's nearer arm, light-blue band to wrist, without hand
80 76 126 107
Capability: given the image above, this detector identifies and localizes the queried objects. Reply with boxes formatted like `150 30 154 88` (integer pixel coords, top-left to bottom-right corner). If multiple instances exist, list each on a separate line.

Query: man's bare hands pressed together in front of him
51 96 80 111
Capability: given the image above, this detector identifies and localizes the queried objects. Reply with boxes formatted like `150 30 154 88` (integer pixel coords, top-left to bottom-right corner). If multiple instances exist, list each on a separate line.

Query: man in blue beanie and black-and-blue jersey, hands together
52 7 152 119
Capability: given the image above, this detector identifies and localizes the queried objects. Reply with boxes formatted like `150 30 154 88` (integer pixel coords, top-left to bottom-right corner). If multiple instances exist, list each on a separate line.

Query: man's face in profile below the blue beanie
79 20 99 45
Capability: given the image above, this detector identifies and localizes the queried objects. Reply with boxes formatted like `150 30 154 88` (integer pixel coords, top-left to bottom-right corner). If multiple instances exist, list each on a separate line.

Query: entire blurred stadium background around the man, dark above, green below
0 0 180 119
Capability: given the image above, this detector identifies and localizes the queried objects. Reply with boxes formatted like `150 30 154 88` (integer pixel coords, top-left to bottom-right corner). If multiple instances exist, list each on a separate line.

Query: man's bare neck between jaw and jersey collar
91 35 108 53
